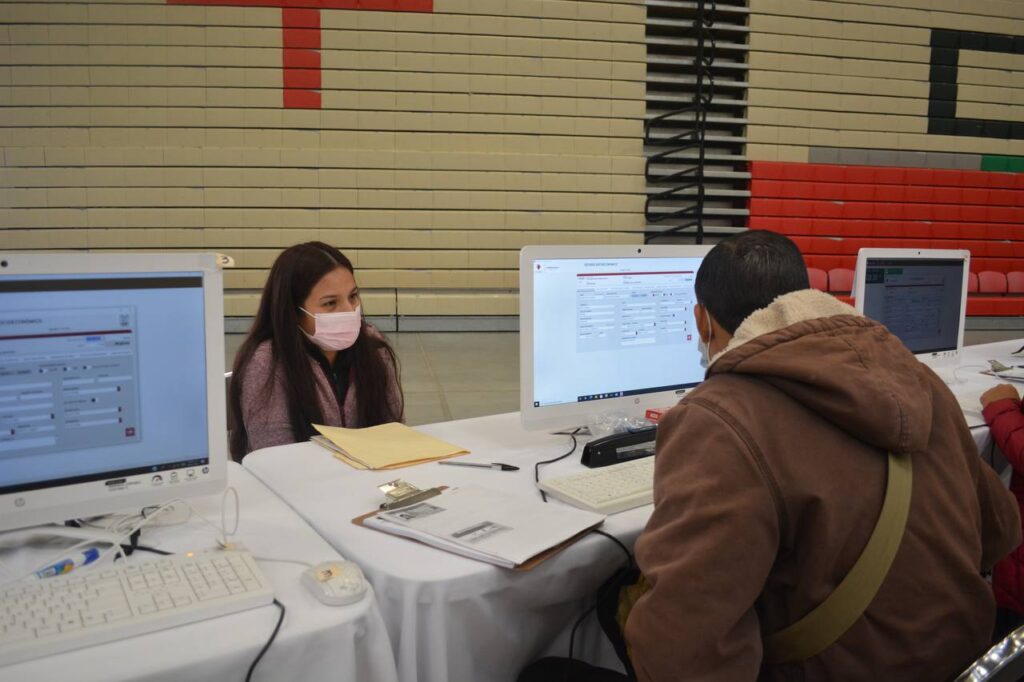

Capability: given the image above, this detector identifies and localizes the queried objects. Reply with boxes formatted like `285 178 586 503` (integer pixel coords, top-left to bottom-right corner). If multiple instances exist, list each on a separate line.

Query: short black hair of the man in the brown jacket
694 229 810 334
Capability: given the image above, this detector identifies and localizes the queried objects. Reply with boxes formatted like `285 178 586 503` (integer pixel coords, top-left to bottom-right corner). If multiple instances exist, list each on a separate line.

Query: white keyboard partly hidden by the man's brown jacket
539 457 654 514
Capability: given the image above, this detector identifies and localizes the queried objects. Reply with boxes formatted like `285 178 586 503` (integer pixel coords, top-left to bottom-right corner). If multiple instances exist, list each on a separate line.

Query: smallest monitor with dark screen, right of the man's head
853 249 971 360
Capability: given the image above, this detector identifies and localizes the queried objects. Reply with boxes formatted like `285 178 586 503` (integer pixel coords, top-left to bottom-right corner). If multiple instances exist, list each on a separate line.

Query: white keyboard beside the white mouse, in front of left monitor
0 552 273 667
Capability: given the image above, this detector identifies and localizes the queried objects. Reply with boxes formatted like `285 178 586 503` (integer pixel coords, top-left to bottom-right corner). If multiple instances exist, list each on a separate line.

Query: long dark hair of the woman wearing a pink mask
227 242 402 461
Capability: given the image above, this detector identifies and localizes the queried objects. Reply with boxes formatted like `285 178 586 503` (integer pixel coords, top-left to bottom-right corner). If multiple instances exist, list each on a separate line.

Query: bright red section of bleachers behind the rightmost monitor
750 161 1024 316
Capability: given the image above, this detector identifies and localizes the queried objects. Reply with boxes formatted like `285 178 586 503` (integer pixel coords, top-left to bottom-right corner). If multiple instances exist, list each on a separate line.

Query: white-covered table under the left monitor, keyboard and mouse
0 464 397 682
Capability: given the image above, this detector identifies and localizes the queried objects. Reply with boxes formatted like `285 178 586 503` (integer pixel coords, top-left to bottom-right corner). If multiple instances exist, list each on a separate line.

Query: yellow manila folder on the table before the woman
311 422 469 469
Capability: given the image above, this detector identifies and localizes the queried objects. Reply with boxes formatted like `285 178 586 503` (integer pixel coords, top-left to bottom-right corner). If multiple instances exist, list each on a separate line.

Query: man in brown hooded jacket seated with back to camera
625 230 1021 682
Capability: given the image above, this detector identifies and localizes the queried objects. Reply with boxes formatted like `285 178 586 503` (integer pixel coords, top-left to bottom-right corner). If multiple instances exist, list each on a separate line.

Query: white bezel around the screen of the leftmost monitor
0 252 227 530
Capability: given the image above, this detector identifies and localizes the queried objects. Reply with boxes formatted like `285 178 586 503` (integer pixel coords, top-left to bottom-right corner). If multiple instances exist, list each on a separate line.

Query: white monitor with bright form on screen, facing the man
519 245 711 429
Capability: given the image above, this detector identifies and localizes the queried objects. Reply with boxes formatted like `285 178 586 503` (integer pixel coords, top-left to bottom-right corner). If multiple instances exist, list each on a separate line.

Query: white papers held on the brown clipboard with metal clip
356 485 604 568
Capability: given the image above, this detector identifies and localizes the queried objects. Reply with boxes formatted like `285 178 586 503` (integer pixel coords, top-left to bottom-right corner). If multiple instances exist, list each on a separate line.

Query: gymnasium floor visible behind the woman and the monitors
225 330 1021 426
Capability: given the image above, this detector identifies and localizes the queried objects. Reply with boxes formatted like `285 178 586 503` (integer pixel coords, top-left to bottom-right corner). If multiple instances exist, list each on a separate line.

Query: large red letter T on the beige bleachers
167 0 434 109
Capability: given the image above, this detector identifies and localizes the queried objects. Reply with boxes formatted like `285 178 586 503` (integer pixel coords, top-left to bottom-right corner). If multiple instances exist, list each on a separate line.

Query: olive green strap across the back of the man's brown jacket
764 453 913 664
